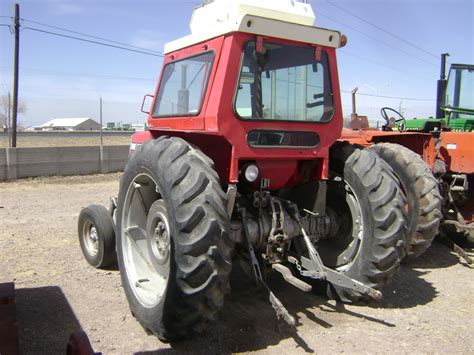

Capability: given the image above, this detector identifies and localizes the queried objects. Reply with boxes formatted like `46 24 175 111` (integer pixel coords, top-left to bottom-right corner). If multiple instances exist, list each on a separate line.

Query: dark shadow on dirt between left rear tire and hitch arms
136 267 326 354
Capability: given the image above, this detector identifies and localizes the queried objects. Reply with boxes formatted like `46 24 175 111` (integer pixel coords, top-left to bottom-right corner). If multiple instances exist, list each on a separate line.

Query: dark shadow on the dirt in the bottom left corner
15 286 82 354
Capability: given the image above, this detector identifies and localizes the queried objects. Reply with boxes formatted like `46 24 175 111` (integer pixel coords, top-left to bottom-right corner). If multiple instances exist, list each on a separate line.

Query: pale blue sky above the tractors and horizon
0 0 474 127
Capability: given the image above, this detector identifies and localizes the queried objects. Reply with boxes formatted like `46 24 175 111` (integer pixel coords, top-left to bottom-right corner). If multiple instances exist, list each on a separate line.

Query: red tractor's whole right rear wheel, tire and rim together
317 143 406 302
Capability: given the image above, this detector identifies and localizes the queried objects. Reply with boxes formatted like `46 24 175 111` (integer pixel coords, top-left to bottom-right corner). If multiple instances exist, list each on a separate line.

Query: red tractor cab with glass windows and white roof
133 0 346 190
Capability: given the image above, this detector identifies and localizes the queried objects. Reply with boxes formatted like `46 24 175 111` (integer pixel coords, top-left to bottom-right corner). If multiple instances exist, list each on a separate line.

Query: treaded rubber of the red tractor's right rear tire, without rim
326 143 406 302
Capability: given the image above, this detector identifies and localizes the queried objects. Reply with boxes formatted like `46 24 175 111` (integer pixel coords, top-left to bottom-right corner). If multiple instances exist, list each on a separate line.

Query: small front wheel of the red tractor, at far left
77 205 117 269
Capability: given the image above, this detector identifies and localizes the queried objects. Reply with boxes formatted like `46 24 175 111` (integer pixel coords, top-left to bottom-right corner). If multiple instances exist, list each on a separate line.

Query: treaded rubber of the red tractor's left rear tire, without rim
117 137 233 341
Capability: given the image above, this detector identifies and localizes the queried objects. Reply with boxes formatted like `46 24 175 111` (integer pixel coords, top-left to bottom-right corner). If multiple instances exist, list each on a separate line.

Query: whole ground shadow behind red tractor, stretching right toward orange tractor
138 244 457 354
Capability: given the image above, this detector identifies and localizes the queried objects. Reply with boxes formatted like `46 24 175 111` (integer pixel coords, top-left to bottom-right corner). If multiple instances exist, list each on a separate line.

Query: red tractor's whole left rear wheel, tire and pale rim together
117 137 232 341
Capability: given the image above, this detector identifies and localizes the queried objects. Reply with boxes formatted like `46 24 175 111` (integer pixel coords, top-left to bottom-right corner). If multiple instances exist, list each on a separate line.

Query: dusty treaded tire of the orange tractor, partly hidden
370 143 442 259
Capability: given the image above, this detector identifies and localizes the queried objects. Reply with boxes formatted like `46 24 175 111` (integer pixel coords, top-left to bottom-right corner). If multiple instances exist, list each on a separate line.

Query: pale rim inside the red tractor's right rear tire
317 176 365 271
